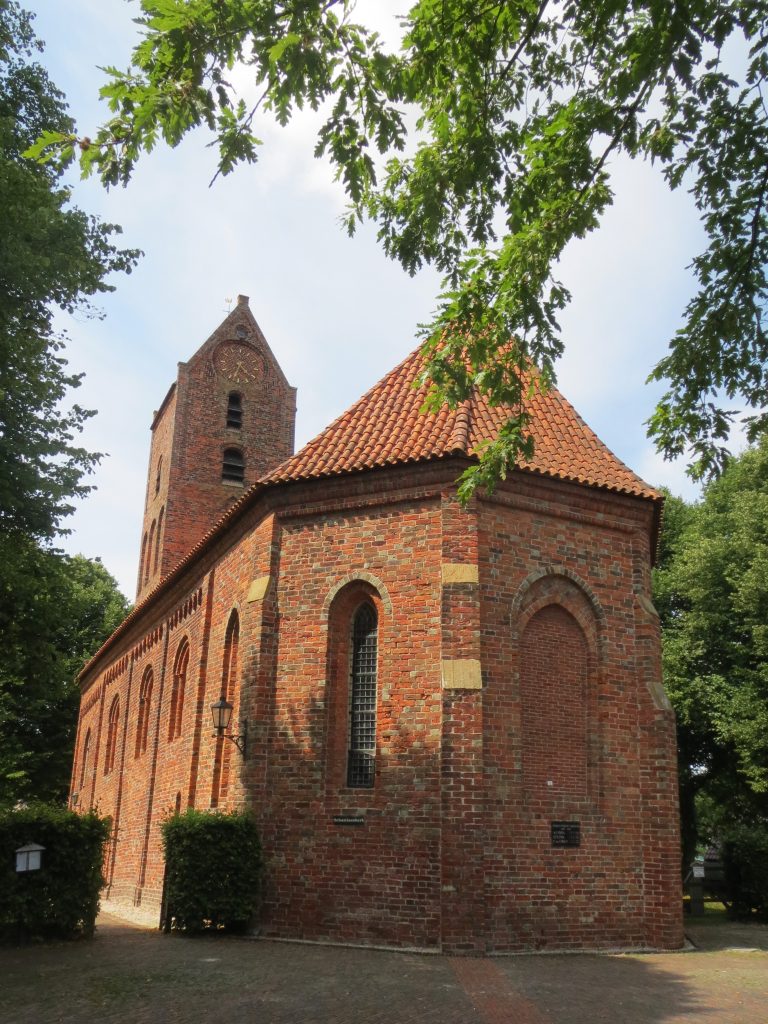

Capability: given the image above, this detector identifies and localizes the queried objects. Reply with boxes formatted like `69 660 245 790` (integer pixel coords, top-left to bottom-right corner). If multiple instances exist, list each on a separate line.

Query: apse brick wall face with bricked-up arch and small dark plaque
480 482 682 950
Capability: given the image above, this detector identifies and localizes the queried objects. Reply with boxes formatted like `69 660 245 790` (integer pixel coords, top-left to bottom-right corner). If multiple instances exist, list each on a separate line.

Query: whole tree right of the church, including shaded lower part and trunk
654 434 768 884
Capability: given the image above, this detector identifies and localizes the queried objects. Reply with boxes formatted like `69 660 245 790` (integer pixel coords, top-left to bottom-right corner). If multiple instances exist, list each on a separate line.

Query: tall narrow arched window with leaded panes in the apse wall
347 602 378 790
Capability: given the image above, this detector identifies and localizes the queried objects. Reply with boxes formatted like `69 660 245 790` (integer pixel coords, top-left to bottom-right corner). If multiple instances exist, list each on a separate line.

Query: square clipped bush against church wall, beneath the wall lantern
162 810 261 934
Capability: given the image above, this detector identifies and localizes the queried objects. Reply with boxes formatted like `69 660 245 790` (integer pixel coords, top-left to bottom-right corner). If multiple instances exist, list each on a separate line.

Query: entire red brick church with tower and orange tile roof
72 296 682 953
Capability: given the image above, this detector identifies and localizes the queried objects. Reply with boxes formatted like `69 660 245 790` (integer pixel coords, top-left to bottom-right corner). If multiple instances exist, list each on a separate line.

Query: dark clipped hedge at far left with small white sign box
0 804 111 942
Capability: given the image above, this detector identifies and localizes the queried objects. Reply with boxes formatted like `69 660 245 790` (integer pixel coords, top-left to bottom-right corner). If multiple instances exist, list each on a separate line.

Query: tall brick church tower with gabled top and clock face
136 295 296 601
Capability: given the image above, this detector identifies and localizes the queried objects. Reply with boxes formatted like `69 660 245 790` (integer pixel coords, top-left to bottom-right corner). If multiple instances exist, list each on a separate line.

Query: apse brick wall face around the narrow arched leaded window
253 491 440 946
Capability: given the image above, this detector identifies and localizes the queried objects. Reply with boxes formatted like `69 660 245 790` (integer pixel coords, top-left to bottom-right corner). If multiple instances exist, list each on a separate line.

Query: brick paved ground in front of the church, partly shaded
0 914 768 1024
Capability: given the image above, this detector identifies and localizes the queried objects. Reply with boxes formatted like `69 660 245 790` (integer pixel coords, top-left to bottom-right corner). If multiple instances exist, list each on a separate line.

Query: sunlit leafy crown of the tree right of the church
655 435 768 794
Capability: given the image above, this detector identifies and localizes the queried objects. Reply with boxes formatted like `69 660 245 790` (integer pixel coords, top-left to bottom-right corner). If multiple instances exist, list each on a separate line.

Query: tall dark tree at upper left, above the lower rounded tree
0 2 138 540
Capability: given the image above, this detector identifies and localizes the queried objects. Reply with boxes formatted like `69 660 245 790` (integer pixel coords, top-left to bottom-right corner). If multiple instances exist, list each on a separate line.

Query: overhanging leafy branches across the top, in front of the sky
35 0 768 495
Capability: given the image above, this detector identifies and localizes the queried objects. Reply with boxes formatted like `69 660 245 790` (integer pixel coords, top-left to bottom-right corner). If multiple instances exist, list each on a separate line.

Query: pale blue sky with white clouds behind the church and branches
24 0 703 598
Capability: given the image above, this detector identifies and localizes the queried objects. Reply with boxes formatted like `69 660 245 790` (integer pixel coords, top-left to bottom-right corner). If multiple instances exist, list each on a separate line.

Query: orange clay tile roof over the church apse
261 349 660 499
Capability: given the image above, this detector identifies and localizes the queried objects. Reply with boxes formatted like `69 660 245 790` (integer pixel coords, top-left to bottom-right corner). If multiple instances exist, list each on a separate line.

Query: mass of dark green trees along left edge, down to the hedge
0 6 137 803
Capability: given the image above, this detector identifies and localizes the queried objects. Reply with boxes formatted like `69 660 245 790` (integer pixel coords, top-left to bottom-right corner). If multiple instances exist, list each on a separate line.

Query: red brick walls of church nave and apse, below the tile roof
73 461 682 952
